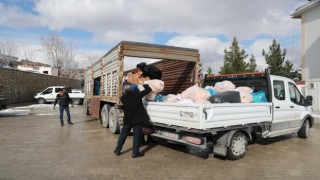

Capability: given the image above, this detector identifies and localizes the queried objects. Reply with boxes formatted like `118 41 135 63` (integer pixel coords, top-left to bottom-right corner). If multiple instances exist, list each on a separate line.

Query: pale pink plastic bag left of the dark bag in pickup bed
181 85 210 103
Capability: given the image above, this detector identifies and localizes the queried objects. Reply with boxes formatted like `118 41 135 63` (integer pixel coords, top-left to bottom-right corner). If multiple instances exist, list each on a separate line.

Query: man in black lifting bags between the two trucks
114 84 151 158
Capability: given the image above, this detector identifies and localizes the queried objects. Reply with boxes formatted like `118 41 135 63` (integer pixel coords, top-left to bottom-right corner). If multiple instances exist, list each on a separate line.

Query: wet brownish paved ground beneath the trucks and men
0 105 320 179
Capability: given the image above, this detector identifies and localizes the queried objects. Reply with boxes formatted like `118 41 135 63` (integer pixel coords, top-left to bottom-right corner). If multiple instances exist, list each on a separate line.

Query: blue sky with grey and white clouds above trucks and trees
0 0 308 73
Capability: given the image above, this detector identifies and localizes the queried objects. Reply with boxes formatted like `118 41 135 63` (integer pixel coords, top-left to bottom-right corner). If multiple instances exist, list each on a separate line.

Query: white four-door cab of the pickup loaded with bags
268 75 313 137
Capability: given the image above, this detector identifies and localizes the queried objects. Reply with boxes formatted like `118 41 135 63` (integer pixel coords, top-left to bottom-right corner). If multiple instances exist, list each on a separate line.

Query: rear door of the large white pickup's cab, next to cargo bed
272 80 293 132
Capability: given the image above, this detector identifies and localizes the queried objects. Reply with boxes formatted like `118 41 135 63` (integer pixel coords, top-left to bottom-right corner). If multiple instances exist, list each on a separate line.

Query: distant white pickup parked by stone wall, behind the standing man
34 86 84 105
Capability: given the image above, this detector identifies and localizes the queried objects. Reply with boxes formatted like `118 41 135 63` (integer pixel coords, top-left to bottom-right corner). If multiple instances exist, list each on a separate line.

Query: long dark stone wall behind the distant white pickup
0 67 81 103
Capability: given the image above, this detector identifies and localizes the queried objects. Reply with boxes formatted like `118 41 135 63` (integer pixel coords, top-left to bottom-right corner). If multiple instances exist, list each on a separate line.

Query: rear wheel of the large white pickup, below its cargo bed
227 131 248 160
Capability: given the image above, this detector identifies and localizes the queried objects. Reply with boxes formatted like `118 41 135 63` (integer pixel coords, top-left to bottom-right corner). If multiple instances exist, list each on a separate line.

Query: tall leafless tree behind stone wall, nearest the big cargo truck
41 34 77 69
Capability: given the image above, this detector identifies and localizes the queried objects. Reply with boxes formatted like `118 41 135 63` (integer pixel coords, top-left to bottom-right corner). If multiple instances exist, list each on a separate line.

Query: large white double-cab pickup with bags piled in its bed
145 72 314 160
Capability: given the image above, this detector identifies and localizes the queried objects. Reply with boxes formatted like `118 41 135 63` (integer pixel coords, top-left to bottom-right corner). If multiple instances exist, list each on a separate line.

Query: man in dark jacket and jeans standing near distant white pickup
53 88 73 126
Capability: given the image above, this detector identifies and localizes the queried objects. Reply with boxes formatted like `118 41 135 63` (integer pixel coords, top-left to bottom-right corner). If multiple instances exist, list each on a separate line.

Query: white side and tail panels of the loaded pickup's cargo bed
145 102 272 130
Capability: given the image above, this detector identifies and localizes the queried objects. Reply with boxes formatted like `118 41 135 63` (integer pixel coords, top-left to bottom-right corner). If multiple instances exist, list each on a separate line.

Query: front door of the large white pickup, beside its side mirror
288 82 306 128
